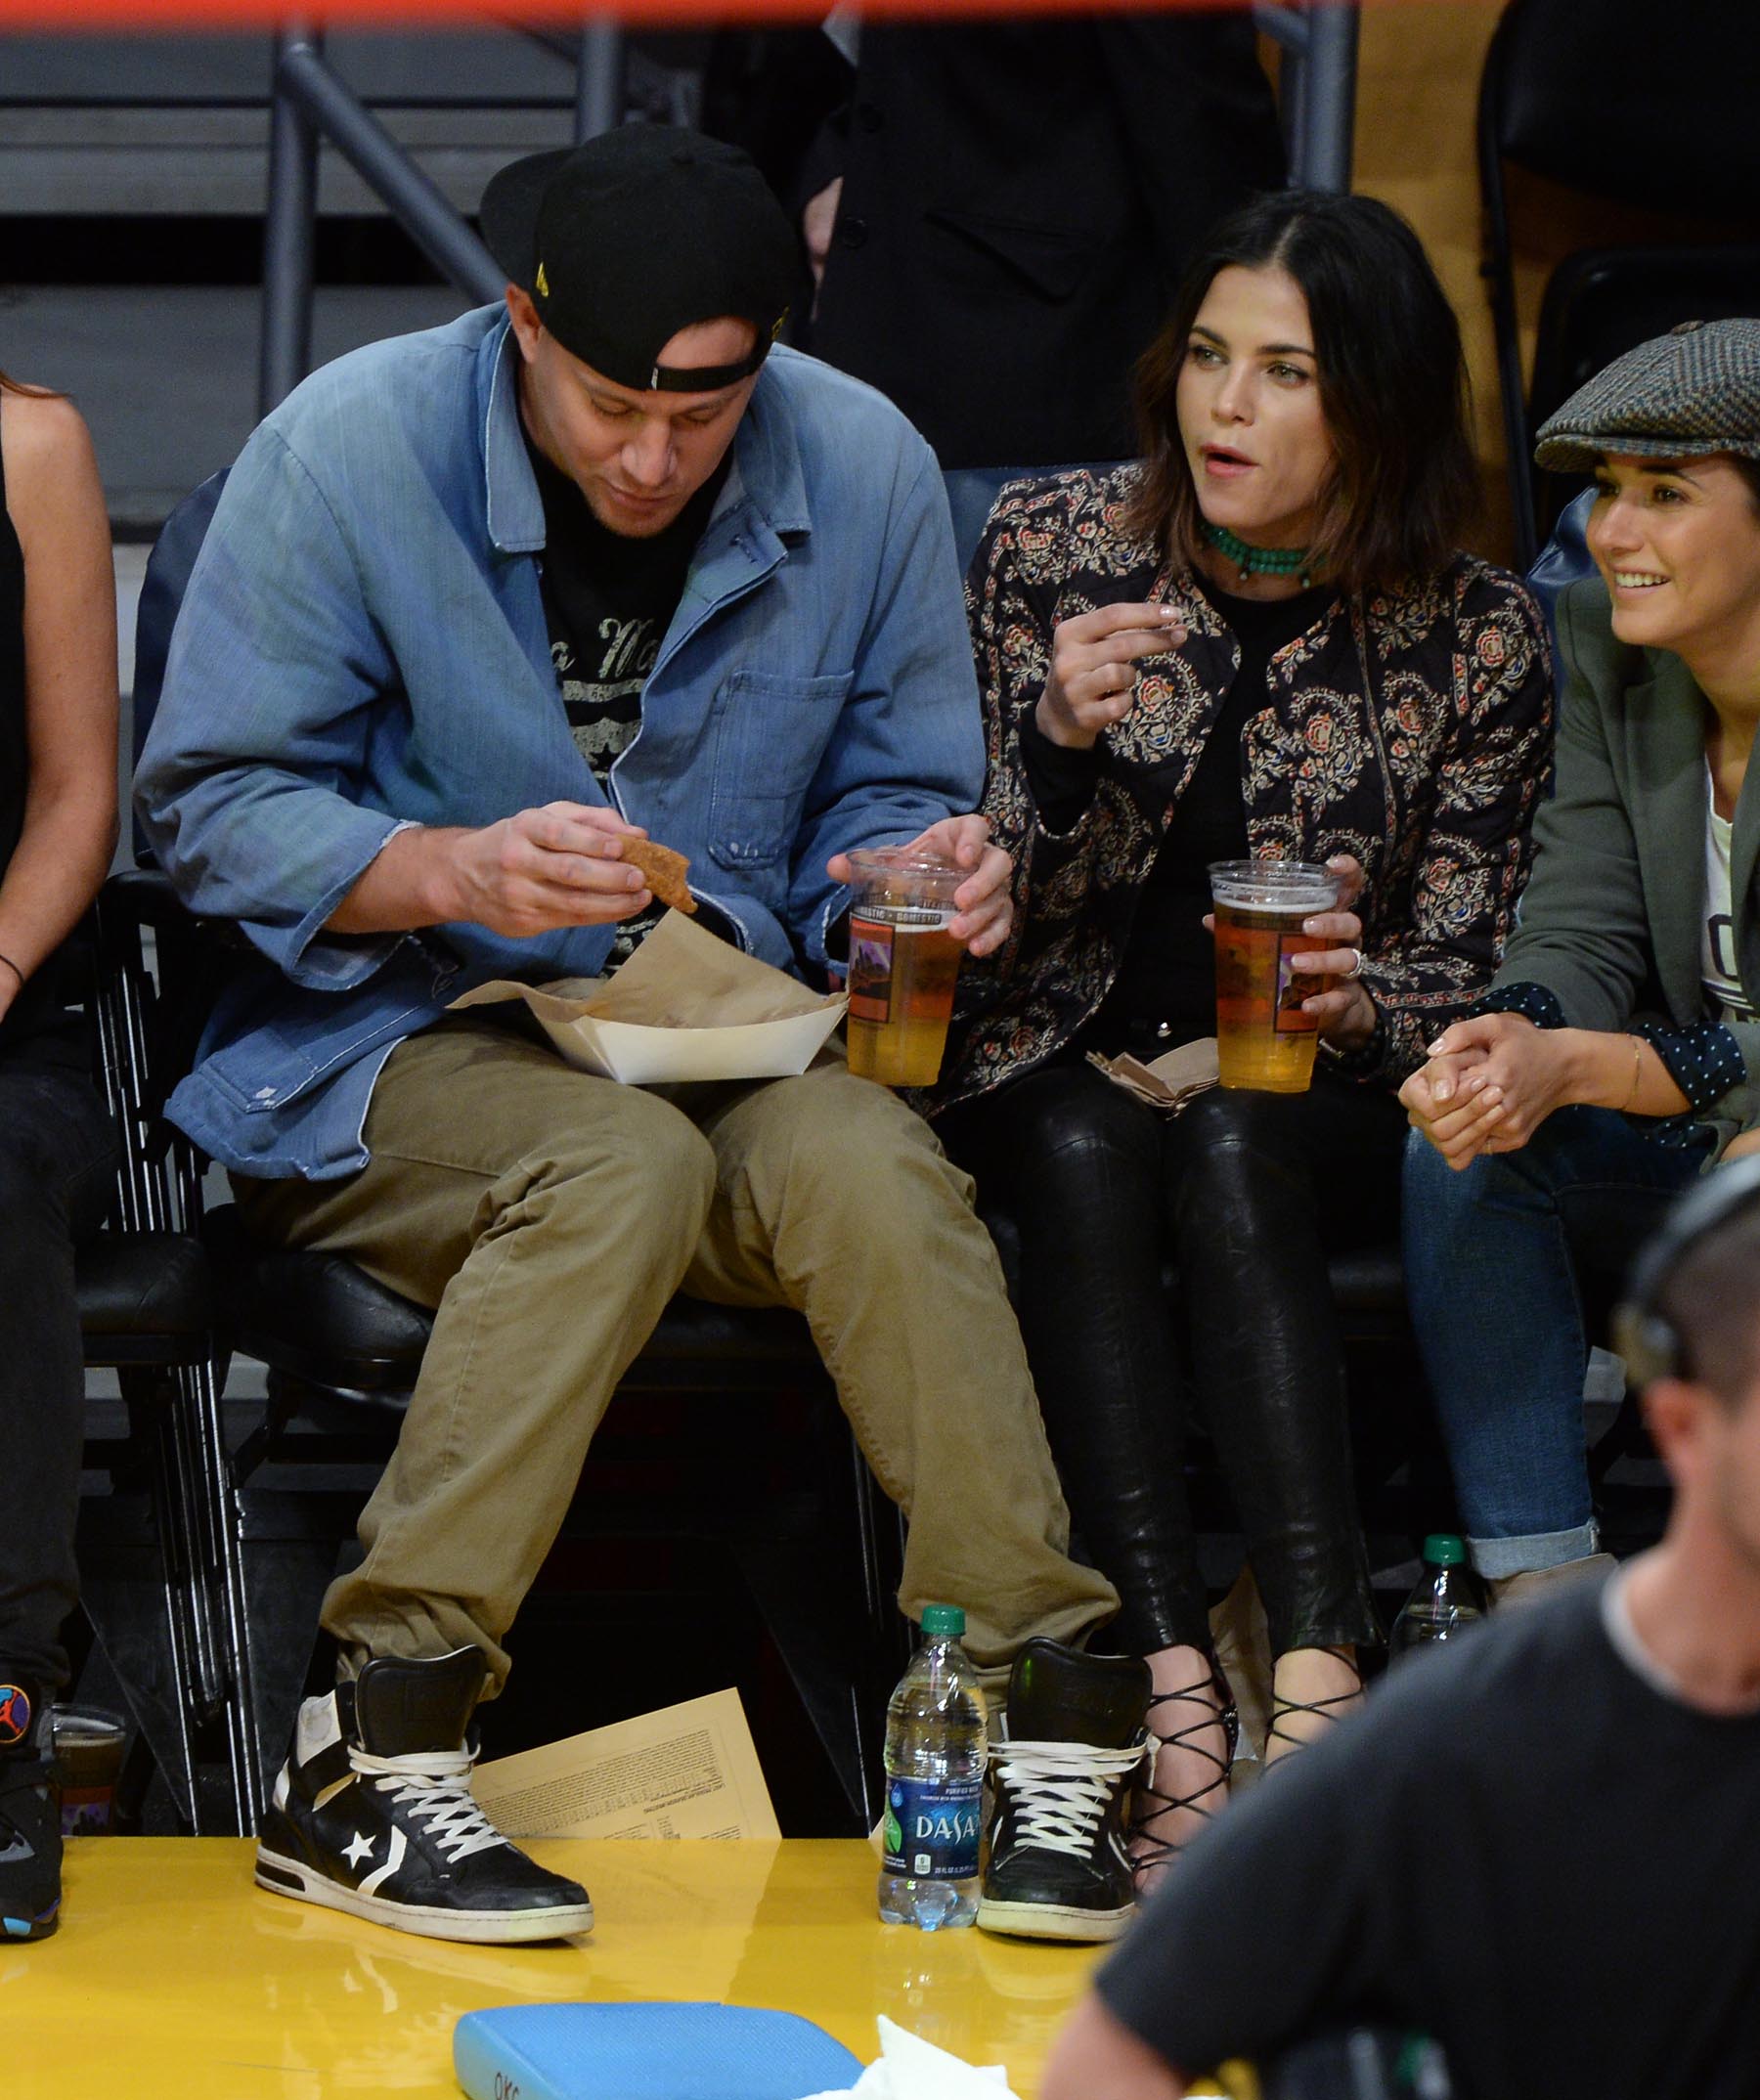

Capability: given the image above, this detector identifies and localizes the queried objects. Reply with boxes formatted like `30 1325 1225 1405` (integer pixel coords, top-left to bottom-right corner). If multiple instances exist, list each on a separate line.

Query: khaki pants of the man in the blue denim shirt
238 1017 1118 1688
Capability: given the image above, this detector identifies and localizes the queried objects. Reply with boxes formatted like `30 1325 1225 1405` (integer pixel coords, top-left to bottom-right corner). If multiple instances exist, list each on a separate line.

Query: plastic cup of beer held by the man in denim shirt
844 847 970 1086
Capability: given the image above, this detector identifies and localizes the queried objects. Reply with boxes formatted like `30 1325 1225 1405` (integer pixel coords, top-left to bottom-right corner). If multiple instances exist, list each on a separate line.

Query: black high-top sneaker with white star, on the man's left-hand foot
256 1648 593 1943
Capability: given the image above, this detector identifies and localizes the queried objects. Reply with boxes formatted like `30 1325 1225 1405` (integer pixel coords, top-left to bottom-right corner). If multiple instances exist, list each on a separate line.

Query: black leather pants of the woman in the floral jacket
939 1065 1405 1655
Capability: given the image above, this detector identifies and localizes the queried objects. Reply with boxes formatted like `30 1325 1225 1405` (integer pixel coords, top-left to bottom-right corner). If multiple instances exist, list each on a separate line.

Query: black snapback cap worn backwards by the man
481 124 800 393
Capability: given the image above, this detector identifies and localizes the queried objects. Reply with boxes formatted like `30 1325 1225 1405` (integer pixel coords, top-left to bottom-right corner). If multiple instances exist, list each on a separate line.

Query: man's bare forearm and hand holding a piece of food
326 803 651 941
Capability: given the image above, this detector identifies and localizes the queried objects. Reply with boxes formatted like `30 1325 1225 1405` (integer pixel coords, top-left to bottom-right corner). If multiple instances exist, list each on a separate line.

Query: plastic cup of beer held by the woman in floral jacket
1210 861 1338 1094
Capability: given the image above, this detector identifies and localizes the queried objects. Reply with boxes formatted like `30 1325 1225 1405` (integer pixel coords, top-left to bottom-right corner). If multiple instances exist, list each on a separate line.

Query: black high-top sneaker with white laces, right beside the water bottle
979 1641 1151 1941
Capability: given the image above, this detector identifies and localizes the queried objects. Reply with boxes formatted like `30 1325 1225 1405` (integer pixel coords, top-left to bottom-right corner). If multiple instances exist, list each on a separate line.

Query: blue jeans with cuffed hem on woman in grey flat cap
1403 1107 1714 1577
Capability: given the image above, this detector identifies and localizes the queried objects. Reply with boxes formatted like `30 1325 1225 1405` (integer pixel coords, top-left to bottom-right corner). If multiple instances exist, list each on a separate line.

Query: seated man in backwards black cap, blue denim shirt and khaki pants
139 128 1127 1941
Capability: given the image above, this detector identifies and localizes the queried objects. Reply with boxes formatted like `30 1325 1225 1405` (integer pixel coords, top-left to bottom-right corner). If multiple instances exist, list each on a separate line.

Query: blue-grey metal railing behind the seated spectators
256 0 1359 416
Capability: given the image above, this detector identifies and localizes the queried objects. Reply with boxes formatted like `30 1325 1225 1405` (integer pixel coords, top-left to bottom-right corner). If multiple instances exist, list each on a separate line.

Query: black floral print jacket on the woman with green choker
933 466 1552 1107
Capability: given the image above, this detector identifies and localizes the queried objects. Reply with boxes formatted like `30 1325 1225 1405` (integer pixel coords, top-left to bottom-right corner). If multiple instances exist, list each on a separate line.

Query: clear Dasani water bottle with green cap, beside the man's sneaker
880 1604 985 1932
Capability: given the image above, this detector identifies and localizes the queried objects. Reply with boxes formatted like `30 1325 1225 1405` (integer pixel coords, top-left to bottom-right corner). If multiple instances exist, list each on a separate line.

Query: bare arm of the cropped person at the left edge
0 393 117 1014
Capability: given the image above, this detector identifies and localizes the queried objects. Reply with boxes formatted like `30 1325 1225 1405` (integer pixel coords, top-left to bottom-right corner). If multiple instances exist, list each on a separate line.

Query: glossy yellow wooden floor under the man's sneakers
0 1838 1094 2100
